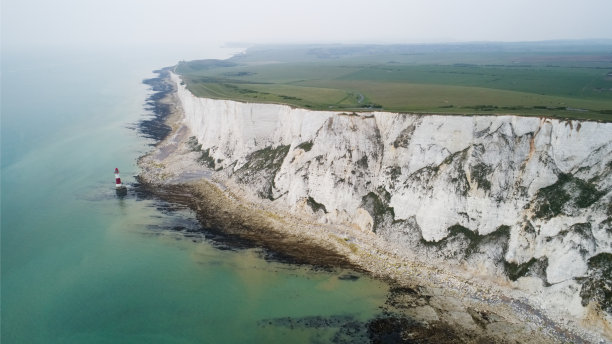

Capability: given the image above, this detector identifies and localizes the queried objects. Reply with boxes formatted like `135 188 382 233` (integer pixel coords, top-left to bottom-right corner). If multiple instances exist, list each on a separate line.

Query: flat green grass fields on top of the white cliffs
175 42 612 121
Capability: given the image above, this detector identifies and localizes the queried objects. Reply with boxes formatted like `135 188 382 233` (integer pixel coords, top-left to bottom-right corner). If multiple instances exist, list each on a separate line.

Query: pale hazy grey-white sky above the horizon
1 0 612 49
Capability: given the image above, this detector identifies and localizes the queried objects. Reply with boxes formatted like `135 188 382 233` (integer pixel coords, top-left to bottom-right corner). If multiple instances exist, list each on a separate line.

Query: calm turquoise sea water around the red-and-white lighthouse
1 52 387 344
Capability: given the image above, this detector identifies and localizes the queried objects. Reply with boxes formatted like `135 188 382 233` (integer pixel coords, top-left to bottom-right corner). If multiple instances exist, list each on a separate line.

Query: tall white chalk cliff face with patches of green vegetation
172 75 612 317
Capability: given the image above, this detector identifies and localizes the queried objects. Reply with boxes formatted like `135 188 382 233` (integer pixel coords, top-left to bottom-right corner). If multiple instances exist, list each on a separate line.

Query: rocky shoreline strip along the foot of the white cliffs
139 68 605 343
